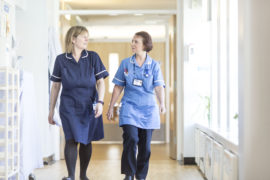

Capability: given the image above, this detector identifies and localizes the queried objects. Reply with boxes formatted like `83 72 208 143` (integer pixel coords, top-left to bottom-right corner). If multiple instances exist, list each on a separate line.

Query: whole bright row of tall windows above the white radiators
184 0 238 139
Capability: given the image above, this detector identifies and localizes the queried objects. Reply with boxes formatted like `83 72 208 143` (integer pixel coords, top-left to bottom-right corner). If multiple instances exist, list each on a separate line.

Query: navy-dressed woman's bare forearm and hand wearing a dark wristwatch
95 78 105 118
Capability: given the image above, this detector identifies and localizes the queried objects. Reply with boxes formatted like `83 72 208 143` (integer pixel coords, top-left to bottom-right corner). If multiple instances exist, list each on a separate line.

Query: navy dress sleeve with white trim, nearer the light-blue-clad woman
94 53 109 80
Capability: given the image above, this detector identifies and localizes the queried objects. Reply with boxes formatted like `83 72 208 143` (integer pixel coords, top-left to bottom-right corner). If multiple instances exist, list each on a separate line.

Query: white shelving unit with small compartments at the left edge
0 67 20 180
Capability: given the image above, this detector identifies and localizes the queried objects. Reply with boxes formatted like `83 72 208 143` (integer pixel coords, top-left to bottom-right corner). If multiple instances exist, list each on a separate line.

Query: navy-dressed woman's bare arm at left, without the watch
48 82 61 125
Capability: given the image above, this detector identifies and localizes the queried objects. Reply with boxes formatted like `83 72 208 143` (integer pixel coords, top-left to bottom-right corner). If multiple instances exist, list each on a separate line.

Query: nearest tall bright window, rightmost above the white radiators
211 0 238 135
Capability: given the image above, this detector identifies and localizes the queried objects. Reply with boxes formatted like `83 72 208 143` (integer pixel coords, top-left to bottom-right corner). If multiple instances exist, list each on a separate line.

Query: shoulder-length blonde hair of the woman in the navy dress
65 26 88 53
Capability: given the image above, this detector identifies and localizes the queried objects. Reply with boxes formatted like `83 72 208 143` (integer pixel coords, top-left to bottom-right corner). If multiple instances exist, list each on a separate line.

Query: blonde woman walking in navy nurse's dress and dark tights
48 26 108 180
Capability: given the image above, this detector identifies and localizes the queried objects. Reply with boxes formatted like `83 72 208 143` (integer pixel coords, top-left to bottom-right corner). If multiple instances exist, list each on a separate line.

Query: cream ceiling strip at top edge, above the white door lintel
60 0 176 10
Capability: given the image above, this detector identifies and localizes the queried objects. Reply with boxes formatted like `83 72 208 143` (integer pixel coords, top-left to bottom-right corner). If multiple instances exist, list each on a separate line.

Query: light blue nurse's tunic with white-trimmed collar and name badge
113 55 164 129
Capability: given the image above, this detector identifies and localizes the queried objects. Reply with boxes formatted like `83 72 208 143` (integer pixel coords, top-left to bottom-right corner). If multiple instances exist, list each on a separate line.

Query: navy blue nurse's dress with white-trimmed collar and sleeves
50 50 109 144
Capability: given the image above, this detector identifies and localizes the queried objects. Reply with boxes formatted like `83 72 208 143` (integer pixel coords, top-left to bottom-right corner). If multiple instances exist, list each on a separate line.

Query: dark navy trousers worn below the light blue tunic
121 125 153 179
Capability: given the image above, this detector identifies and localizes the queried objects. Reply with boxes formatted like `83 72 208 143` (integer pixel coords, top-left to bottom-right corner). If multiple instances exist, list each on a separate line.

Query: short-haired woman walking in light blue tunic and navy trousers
107 31 166 180
